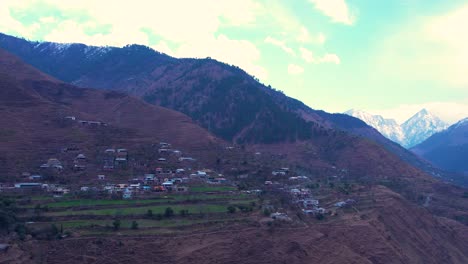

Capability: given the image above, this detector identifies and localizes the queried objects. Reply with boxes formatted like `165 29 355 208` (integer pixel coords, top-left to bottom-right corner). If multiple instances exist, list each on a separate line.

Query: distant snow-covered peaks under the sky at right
345 109 448 148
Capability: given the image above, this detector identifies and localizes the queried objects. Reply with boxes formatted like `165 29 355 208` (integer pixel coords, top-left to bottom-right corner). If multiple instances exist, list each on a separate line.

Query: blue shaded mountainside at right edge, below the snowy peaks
411 119 468 174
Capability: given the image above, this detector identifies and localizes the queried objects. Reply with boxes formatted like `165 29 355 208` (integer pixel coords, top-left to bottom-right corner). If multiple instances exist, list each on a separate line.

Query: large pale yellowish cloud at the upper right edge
374 5 468 89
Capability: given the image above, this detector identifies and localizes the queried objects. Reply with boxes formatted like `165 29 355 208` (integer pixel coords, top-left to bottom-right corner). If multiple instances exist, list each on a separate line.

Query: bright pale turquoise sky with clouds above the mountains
0 0 468 123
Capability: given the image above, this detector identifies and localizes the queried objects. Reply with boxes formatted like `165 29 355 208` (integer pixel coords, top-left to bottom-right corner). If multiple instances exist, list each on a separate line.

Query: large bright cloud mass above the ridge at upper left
0 0 268 81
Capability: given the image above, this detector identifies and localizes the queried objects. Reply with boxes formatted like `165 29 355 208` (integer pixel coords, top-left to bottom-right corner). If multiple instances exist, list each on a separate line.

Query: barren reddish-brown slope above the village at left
0 48 221 180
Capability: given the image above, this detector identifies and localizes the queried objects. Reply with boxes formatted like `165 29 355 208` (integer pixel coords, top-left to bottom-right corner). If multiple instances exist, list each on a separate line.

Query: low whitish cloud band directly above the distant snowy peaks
368 101 468 124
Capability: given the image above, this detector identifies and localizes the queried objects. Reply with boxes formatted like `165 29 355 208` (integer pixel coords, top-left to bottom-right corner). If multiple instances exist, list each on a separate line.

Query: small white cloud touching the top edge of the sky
309 0 355 25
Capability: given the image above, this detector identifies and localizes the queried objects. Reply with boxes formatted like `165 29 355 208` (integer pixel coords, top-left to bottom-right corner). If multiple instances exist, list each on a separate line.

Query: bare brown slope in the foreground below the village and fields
9 187 468 264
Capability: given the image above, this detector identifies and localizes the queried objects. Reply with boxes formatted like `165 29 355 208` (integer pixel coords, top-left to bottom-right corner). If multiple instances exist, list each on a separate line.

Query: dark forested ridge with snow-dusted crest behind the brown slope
0 35 434 179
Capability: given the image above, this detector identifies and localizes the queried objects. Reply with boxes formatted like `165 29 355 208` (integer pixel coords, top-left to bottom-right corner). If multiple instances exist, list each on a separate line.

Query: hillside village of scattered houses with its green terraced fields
0 117 362 235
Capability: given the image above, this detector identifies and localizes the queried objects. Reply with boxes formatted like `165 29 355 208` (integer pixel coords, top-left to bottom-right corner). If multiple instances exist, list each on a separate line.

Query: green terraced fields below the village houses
23 186 259 235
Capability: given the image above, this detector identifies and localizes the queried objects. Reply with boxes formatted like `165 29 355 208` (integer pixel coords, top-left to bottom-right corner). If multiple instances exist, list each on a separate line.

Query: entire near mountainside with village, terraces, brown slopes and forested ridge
0 35 468 263
